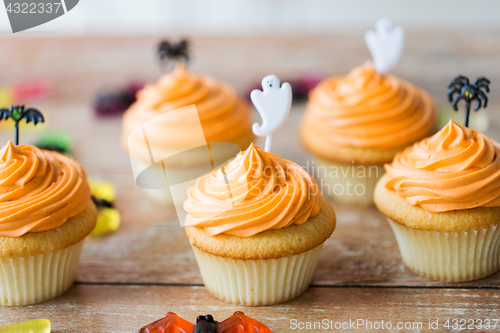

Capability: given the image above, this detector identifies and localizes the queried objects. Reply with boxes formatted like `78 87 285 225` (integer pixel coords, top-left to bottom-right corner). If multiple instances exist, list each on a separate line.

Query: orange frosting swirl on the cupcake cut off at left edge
0 142 90 237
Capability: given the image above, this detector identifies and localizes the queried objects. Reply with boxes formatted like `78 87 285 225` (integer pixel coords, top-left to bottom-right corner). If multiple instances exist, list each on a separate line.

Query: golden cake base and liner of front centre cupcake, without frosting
186 200 336 306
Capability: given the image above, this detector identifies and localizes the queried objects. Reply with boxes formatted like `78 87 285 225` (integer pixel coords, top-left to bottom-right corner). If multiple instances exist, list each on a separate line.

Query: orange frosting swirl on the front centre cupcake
184 144 321 237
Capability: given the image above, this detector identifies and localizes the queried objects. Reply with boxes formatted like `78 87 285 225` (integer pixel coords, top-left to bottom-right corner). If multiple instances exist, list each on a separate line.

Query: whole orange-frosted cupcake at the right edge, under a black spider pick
375 121 500 282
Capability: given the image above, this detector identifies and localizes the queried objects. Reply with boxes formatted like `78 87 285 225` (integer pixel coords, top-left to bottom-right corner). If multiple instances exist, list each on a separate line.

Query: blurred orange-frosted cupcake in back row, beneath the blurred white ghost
299 63 436 204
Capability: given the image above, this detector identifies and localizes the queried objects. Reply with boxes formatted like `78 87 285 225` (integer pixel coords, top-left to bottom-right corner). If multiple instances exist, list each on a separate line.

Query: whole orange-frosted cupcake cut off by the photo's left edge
0 142 97 306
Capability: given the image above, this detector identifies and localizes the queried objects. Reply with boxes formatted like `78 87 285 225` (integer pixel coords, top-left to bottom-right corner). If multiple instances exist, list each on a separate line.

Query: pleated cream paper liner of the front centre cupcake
192 244 323 306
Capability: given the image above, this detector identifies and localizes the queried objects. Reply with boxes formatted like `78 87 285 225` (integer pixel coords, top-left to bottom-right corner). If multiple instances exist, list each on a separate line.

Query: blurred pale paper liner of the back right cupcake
314 158 385 205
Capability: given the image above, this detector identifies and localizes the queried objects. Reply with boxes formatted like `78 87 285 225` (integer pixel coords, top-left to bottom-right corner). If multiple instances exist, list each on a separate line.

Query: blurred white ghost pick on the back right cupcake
365 19 405 74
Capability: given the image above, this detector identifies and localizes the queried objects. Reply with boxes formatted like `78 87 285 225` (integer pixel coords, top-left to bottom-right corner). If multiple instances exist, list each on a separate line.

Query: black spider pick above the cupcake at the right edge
448 75 490 127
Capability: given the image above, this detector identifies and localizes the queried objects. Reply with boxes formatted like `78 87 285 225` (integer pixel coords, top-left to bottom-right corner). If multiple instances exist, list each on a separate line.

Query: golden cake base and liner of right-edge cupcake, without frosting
375 176 500 282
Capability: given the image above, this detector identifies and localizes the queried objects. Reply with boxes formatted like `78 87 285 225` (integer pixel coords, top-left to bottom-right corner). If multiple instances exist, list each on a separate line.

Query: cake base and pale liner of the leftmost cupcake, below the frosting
0 201 97 306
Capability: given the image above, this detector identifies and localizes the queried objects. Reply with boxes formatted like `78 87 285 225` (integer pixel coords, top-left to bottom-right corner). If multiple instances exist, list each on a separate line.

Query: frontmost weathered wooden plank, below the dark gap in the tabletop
0 285 500 333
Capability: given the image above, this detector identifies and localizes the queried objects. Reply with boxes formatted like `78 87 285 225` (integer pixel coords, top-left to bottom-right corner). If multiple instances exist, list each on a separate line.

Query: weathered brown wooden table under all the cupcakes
0 35 500 332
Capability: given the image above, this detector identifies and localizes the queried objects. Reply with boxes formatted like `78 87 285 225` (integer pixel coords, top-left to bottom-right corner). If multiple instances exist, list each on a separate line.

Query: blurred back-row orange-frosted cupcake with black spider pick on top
122 63 254 204
